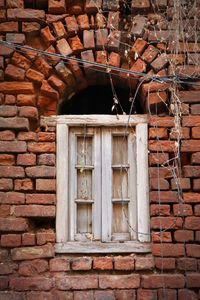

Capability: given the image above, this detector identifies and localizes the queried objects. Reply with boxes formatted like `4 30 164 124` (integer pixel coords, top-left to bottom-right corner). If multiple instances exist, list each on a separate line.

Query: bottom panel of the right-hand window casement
112 203 129 233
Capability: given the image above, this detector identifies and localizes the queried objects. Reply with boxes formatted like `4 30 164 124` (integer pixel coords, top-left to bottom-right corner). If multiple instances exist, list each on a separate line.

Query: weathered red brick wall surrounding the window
0 0 200 300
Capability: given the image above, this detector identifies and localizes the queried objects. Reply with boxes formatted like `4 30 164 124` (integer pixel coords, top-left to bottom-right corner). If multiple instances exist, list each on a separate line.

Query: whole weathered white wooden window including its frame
56 115 149 253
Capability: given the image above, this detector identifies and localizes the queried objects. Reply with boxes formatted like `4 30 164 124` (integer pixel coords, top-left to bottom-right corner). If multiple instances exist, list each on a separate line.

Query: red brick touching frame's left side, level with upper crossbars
26 166 55 178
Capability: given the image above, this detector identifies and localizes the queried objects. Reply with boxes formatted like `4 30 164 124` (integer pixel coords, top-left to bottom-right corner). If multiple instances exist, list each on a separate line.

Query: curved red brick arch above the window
1 0 172 115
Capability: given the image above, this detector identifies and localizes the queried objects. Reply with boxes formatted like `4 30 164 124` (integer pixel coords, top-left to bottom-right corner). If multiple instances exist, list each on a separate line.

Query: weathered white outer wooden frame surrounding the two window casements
54 115 150 253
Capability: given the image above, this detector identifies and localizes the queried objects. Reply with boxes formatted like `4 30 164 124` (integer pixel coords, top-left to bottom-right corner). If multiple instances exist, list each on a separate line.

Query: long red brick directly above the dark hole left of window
13 204 55 217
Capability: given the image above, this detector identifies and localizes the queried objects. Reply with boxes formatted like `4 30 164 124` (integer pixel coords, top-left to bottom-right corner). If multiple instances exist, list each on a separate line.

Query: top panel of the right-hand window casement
112 136 128 165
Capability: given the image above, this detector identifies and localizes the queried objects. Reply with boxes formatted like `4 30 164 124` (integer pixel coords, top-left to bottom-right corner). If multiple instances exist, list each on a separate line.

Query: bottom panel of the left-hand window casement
77 204 92 233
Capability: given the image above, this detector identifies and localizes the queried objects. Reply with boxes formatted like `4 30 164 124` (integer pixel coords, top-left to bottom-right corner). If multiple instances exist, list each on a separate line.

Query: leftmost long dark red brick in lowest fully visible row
10 276 53 291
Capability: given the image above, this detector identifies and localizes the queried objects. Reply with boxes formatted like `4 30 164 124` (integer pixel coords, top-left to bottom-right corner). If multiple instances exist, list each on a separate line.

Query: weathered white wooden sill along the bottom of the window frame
55 242 151 253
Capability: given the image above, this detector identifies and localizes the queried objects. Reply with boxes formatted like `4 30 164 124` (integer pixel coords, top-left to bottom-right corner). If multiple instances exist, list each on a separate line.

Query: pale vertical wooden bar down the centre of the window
101 128 112 242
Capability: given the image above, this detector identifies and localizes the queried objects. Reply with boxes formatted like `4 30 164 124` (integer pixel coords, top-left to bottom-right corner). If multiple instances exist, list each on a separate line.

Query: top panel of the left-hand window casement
77 137 92 167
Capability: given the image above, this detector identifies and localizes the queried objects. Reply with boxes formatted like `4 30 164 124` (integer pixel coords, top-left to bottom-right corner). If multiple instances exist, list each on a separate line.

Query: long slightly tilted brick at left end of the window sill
11 244 54 260
